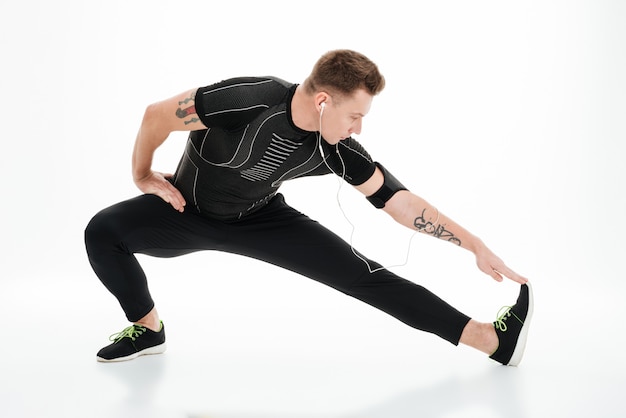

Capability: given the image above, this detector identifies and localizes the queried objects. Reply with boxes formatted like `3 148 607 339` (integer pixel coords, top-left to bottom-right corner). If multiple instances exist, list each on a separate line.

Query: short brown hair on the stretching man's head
304 49 385 96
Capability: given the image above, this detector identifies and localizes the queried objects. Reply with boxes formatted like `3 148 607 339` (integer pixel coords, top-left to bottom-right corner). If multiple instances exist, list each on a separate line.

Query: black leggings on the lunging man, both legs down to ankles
85 194 470 344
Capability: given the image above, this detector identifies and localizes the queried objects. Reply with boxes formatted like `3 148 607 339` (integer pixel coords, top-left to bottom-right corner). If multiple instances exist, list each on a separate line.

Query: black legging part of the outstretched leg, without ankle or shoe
213 196 470 344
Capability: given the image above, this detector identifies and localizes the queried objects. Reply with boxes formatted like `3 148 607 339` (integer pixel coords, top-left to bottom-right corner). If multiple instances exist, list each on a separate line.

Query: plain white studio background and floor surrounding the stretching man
0 0 626 417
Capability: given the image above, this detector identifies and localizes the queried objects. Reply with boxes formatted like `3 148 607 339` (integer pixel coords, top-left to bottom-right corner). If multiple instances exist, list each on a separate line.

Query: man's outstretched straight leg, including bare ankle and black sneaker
217 196 532 365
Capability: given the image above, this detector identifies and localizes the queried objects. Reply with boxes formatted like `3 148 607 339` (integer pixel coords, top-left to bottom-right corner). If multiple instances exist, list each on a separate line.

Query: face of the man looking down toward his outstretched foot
321 89 373 145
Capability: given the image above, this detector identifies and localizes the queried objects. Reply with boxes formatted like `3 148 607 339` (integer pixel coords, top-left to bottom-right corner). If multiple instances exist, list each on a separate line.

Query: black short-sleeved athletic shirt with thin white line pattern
172 77 375 221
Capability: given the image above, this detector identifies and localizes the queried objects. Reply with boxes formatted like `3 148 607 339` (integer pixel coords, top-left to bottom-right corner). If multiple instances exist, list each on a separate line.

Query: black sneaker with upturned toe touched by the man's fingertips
489 283 533 366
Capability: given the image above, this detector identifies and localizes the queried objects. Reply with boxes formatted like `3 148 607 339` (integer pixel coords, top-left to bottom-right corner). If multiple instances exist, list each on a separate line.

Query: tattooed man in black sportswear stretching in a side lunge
85 50 532 365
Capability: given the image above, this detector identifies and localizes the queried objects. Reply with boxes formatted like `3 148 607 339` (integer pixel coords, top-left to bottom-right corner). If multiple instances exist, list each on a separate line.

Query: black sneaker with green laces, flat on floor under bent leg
97 322 166 362
